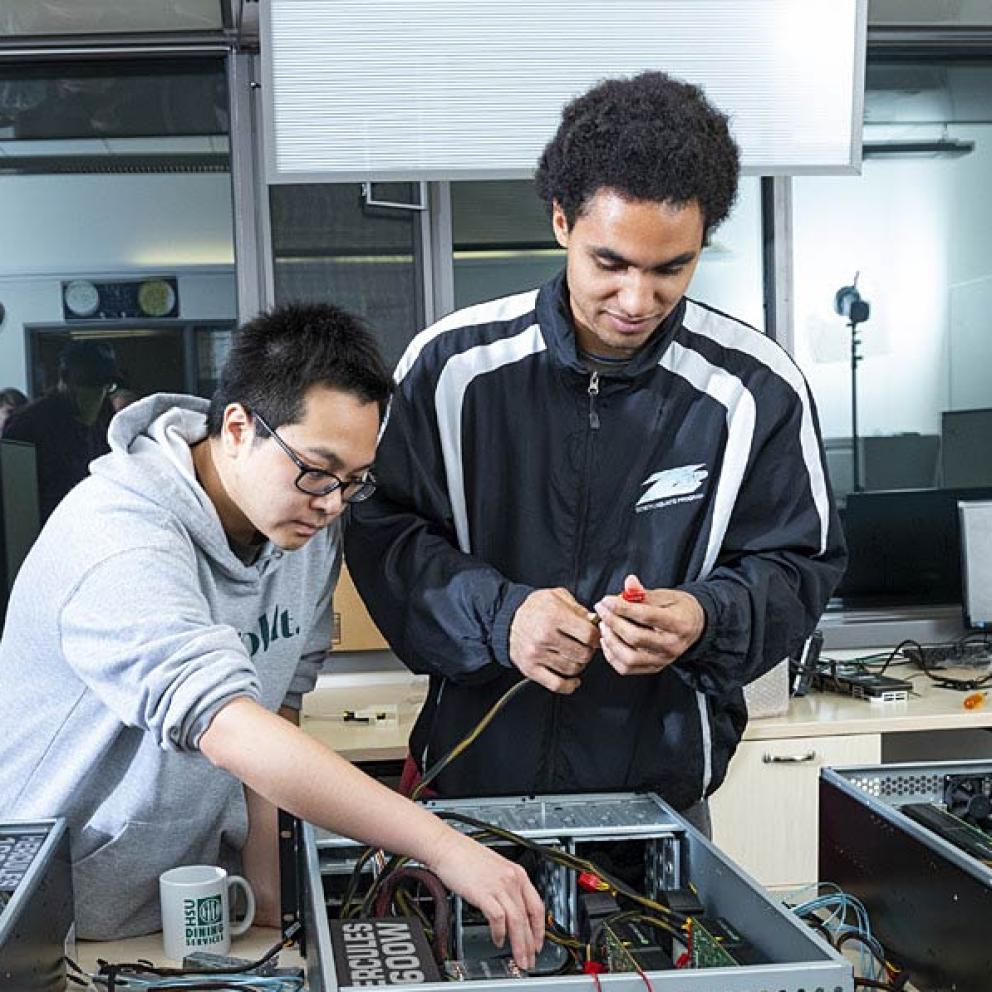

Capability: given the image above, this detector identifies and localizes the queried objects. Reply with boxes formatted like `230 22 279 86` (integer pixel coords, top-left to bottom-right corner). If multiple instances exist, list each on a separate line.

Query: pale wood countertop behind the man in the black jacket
303 666 992 761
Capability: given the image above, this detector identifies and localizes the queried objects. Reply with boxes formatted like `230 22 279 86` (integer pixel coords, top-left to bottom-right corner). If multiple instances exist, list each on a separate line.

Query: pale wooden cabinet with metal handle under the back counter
710 734 882 888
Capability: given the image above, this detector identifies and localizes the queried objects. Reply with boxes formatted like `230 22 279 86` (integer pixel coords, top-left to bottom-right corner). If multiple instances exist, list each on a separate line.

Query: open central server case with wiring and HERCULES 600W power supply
284 793 853 992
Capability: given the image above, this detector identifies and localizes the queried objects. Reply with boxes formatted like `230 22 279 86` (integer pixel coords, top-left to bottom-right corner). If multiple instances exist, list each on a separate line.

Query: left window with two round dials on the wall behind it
0 54 237 615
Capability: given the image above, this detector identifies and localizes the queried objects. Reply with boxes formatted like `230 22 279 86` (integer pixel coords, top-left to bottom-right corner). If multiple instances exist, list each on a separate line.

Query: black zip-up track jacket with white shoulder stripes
346 275 846 809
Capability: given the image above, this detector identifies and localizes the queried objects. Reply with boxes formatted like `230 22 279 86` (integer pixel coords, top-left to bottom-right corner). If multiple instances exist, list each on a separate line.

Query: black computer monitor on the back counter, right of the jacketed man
837 486 992 608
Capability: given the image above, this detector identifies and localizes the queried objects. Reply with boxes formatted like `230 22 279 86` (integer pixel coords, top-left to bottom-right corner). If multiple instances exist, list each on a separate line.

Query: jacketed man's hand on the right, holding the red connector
596 575 706 675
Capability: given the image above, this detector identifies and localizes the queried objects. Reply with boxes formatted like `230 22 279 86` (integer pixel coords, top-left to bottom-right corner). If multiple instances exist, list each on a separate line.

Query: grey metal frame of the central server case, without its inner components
297 793 854 992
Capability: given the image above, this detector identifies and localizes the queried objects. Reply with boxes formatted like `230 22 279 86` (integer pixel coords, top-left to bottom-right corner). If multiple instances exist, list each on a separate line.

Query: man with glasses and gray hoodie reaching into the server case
0 305 544 967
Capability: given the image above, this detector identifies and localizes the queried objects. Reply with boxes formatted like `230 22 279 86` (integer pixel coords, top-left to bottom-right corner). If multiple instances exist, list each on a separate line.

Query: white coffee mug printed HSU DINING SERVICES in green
158 865 255 961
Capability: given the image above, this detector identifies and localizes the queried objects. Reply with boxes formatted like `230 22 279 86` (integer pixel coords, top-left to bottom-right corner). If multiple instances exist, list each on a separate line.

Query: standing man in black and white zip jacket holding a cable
346 72 845 829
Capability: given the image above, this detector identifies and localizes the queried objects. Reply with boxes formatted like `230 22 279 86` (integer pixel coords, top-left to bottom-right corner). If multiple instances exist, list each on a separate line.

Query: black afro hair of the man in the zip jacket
534 72 740 235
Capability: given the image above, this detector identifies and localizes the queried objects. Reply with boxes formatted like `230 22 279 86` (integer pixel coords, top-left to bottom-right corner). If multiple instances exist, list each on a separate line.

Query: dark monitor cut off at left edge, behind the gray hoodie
0 438 41 622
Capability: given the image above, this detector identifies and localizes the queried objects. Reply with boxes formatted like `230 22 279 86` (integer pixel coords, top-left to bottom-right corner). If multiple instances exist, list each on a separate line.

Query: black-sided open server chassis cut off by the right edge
820 761 992 992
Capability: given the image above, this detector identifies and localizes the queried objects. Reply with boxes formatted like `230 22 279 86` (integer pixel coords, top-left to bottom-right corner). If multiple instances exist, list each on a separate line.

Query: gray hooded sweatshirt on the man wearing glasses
0 394 340 939
